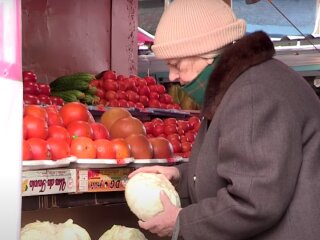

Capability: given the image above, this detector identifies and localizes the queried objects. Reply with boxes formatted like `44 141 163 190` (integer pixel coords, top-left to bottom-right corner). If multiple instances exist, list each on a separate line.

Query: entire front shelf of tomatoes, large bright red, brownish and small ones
23 102 200 160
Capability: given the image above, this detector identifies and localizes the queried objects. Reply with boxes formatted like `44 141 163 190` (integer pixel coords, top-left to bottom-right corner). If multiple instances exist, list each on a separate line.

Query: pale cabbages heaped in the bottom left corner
21 219 91 240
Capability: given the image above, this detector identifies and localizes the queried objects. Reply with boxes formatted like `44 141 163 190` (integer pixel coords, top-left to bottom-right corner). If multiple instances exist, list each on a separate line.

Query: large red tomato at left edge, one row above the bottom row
23 115 48 139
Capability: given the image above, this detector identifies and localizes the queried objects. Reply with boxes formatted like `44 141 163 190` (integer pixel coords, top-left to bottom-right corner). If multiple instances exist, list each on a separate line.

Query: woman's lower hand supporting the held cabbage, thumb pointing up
138 191 181 237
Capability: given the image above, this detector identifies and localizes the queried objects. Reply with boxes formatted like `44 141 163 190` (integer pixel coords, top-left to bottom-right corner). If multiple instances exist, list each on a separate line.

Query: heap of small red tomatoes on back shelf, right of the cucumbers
91 70 181 109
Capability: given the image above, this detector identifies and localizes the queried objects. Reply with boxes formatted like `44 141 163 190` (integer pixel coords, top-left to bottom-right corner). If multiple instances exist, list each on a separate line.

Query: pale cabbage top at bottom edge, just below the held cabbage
99 225 147 240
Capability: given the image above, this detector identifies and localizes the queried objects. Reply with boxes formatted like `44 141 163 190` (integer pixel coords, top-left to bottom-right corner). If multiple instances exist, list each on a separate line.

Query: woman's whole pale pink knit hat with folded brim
152 0 246 59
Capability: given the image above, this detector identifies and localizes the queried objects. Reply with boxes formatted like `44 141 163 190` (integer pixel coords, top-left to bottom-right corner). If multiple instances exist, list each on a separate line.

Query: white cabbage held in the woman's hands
125 173 181 221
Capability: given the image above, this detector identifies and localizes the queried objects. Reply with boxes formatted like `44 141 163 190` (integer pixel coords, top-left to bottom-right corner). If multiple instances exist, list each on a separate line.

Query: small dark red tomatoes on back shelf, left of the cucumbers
22 71 64 106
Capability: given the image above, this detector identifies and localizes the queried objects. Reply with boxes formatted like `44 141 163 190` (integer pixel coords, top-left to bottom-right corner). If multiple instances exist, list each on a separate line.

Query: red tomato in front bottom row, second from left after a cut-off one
27 138 51 160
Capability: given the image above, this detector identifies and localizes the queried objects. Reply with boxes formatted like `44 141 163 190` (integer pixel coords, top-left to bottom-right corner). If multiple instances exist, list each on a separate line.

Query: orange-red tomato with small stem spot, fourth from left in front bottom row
70 137 96 159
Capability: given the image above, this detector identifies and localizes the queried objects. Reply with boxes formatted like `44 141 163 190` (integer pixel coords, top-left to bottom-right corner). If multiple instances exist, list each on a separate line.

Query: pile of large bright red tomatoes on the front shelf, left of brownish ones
23 102 130 160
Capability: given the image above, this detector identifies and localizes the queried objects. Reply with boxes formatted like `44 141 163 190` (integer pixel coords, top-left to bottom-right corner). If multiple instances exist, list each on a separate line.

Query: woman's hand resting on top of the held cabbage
128 165 180 181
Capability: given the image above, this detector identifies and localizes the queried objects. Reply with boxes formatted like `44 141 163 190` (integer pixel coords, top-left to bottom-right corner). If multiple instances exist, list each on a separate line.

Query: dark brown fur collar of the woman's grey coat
202 31 275 120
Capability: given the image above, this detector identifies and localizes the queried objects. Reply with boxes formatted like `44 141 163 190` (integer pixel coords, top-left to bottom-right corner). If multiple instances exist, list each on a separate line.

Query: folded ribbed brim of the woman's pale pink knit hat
152 19 246 59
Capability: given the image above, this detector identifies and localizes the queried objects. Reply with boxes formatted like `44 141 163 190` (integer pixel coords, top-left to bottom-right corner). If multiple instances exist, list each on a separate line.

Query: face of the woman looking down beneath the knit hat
167 56 213 85
